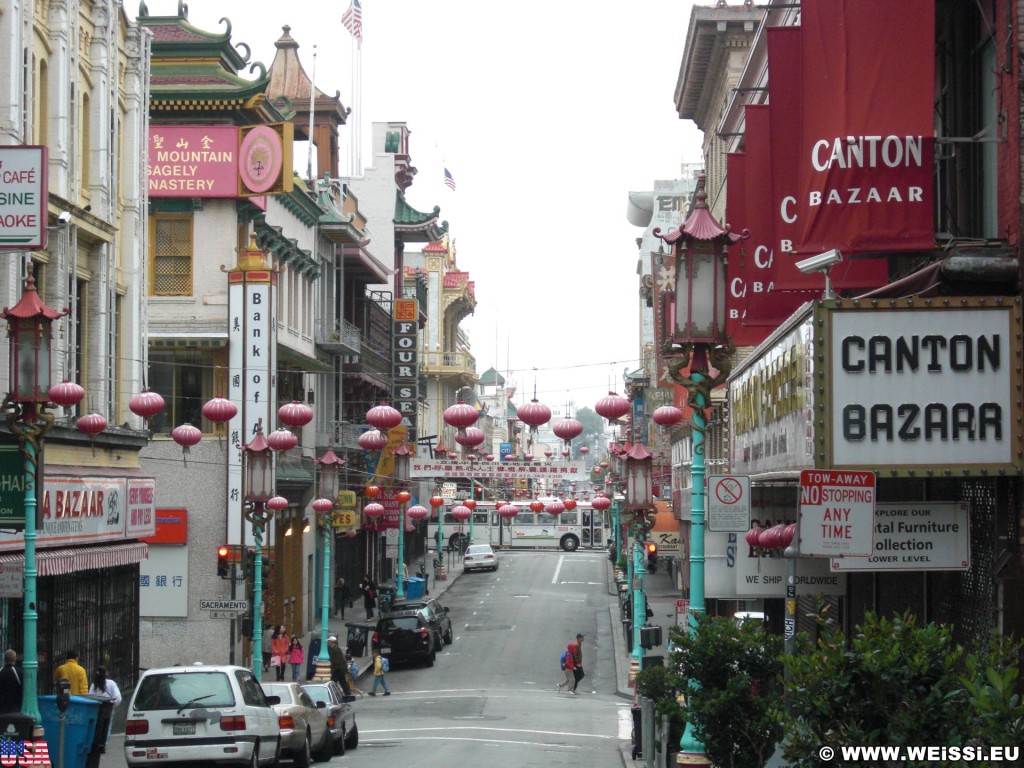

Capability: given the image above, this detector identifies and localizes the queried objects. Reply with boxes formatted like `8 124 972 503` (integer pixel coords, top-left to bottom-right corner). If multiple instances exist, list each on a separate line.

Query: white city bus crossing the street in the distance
427 499 609 552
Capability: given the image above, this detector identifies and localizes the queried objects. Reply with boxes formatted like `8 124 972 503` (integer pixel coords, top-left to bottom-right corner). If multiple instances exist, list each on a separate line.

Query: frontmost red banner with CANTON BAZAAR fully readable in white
798 0 935 256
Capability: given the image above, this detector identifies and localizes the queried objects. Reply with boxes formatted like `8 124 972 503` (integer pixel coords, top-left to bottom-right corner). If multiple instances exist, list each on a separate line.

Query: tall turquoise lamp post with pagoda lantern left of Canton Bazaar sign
654 174 748 765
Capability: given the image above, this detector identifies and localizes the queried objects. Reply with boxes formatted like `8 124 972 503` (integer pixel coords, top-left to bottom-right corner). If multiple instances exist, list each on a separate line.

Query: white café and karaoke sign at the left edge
0 146 49 251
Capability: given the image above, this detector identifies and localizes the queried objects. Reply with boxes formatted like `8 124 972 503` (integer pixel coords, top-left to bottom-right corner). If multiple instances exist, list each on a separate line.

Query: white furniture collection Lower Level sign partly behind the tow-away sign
831 502 971 571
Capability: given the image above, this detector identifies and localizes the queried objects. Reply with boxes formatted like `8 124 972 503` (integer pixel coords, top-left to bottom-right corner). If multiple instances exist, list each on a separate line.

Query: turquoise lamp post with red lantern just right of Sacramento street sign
242 422 288 681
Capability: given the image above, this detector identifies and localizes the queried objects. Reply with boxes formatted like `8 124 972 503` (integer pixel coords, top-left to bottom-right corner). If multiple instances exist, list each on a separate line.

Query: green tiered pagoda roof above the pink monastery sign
138 0 282 117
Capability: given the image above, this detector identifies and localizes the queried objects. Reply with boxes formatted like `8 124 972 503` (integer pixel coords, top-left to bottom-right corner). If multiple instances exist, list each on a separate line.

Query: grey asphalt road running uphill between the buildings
100 551 630 768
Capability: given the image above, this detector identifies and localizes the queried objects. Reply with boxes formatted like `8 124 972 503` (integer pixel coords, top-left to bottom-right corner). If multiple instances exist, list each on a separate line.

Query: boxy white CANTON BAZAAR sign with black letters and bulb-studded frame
815 299 1022 475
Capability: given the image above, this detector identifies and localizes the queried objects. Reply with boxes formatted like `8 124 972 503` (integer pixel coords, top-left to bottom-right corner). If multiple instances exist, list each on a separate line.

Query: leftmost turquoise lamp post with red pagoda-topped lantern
0 265 80 724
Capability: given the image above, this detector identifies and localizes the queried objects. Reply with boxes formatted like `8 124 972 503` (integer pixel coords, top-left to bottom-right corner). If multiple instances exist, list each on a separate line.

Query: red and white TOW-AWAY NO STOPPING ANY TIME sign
800 469 877 557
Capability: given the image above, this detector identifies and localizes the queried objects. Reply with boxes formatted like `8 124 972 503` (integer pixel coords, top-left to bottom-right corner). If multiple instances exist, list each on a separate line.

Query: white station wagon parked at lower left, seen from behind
125 665 281 768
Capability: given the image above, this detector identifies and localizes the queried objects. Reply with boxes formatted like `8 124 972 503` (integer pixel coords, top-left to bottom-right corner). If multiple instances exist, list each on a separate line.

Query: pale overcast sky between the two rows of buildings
136 0 700 415
